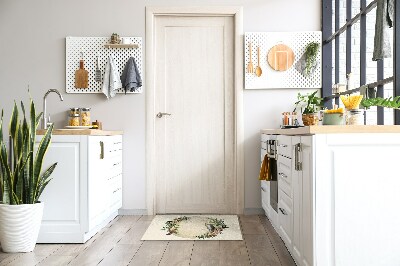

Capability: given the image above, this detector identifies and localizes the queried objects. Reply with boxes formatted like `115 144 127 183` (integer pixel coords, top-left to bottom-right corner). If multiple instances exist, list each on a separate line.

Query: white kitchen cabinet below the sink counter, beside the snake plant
38 135 122 243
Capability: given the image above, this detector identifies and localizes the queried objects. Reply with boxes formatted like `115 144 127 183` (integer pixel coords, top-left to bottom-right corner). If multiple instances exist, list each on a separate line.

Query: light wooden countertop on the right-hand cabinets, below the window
260 125 400 135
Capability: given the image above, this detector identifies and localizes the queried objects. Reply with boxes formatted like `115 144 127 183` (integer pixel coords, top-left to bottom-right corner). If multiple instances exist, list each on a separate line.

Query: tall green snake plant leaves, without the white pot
0 100 57 205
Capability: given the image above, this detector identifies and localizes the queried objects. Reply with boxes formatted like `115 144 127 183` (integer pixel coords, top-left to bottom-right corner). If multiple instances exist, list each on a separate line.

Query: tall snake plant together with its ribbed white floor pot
0 100 57 252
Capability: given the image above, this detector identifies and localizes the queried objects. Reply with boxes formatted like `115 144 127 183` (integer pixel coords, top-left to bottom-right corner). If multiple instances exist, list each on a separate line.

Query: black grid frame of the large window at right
322 0 400 125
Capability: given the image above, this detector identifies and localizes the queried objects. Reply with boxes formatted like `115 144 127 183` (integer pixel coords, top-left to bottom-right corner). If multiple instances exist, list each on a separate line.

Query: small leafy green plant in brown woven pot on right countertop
293 91 323 126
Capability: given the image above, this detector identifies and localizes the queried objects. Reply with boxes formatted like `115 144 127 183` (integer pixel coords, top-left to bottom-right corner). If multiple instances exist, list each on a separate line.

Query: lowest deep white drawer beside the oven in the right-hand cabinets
278 190 293 249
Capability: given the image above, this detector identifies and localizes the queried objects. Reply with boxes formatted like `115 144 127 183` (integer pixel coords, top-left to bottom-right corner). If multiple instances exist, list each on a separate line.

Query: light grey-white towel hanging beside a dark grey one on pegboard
102 55 122 99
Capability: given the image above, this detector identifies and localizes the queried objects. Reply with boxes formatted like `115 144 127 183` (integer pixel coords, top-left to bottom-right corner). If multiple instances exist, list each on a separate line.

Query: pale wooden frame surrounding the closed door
145 6 244 215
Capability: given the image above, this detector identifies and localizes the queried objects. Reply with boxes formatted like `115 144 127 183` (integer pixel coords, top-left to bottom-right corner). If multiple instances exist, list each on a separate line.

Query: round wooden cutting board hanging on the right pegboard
267 44 295 71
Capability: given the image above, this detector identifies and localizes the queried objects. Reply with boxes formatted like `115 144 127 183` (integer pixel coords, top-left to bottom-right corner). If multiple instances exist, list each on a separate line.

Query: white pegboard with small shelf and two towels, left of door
65 37 143 93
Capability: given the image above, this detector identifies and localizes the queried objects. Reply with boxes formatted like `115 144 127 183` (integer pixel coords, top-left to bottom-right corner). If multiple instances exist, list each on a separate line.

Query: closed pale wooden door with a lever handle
154 16 236 213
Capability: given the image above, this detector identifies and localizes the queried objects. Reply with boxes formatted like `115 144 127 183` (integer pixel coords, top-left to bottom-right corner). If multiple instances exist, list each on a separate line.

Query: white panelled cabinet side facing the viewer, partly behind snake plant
35 135 87 243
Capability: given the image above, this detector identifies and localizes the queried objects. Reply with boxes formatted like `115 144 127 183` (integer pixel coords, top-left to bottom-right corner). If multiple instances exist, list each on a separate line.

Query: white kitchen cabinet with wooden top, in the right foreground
262 126 400 266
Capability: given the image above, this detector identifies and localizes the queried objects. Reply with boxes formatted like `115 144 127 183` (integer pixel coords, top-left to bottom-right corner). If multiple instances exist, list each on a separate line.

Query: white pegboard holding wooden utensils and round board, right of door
244 31 322 89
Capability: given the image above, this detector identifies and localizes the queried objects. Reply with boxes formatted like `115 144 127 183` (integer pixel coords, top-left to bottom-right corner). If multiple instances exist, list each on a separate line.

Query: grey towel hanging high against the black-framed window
372 0 394 61
